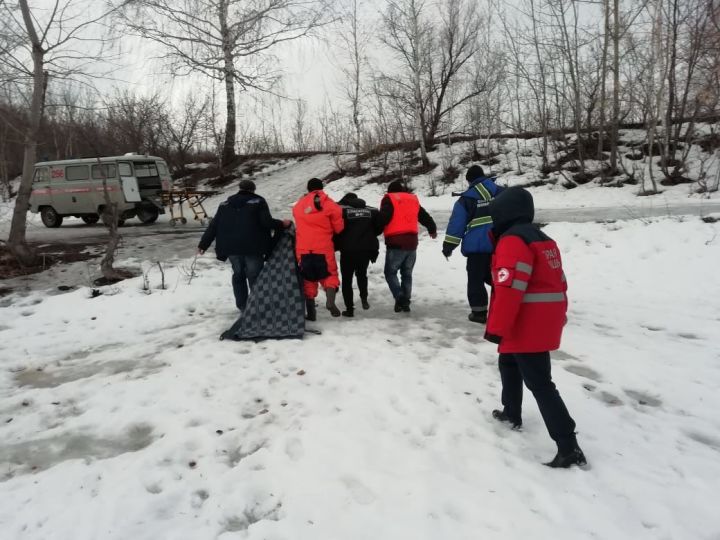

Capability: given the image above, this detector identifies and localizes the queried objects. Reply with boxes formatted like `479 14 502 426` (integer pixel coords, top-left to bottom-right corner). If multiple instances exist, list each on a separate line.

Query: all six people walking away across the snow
198 165 586 468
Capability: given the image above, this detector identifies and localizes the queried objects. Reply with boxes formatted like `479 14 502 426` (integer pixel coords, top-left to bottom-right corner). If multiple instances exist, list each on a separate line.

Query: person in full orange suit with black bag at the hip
293 178 344 321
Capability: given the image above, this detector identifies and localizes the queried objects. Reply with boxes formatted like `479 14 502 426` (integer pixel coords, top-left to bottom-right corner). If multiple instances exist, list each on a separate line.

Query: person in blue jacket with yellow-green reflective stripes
443 165 503 324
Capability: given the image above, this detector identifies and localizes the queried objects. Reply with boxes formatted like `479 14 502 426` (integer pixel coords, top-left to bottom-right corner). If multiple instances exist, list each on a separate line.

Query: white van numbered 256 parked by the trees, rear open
30 154 172 227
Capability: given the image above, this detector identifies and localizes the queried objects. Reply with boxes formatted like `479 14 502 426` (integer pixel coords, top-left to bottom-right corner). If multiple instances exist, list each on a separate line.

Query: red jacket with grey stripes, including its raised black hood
486 188 568 353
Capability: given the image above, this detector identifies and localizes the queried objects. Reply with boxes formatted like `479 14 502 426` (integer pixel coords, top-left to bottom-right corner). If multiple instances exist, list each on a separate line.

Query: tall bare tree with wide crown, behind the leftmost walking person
124 0 329 165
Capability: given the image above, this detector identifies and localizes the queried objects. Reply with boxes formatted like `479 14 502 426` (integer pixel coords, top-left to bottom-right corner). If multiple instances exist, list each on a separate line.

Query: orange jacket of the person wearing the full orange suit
293 190 344 255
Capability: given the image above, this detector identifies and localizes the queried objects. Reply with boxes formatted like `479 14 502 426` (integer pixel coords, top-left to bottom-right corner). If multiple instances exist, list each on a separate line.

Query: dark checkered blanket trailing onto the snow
220 230 305 340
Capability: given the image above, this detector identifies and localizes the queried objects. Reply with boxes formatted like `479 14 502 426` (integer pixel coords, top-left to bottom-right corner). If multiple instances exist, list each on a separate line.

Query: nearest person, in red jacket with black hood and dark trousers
485 187 586 468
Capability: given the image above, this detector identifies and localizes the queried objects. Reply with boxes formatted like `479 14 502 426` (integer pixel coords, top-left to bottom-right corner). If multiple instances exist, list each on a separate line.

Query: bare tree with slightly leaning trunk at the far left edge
0 0 121 264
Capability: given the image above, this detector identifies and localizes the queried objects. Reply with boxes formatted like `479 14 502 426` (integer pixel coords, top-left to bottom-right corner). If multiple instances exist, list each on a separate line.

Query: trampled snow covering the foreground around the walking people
0 212 720 540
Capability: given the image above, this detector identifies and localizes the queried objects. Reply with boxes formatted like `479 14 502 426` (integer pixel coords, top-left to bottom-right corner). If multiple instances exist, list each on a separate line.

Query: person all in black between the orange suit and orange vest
335 193 383 317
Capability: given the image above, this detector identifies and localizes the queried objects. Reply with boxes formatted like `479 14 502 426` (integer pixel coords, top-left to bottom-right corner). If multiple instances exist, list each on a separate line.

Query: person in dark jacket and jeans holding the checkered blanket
198 180 290 311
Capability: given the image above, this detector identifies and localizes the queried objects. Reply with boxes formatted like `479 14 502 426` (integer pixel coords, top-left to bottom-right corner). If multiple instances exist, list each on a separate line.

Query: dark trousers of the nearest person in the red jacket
498 352 575 452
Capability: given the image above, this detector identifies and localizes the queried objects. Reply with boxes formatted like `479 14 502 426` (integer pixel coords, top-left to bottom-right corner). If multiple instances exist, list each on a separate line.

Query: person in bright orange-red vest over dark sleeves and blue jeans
380 180 437 313
